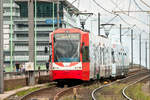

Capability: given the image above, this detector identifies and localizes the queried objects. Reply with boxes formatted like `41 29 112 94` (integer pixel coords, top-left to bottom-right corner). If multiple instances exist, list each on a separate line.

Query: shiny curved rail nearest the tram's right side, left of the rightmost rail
92 72 148 100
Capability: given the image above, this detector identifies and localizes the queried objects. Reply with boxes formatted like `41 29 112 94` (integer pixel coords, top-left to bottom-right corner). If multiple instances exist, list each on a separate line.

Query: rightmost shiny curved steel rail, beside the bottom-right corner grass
122 75 150 100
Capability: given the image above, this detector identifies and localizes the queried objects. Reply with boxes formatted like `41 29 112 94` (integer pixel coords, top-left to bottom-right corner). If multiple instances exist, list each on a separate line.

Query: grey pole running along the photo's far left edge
0 0 4 94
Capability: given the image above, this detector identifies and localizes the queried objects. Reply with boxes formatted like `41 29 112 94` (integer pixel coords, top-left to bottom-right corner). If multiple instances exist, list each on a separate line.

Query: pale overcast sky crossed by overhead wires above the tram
69 0 150 66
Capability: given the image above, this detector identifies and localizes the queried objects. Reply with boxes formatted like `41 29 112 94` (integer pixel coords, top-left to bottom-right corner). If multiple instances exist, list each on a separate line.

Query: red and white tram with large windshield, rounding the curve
47 28 129 81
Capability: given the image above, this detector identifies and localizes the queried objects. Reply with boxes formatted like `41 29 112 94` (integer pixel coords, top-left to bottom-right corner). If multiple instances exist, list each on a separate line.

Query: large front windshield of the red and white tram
54 33 80 62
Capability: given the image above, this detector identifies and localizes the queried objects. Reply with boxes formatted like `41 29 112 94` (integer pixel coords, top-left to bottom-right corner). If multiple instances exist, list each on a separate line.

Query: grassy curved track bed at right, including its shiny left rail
91 71 148 100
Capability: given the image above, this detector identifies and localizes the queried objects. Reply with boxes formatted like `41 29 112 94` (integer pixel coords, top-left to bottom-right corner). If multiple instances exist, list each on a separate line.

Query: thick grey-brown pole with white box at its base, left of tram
28 0 35 85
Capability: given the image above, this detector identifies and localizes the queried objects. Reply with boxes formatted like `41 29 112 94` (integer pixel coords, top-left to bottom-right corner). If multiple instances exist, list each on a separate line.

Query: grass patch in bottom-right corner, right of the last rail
126 83 150 100
